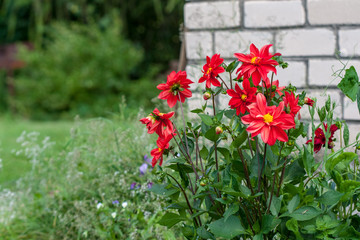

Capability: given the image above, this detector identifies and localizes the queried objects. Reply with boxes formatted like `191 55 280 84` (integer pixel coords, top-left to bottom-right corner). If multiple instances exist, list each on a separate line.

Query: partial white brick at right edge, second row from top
339 29 360 57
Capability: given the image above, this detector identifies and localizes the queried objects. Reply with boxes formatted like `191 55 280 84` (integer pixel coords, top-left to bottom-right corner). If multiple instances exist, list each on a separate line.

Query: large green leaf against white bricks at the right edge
338 66 359 102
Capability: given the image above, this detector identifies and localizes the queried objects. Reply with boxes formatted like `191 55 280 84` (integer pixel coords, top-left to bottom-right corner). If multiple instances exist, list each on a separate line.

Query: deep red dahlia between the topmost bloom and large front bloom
227 80 257 115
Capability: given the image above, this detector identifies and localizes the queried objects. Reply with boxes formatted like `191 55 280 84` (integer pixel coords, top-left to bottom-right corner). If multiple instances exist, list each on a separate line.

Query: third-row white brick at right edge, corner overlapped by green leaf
309 59 360 86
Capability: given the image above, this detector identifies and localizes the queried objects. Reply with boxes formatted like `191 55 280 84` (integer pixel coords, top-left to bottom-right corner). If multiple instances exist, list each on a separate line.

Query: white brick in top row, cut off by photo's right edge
307 0 360 25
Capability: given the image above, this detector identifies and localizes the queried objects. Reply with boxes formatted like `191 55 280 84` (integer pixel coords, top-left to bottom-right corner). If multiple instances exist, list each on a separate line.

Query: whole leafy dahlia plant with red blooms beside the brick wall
140 44 360 239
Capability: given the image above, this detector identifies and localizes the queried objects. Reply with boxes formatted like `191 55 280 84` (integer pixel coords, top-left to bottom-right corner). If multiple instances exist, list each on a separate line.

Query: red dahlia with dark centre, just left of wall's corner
157 71 193 108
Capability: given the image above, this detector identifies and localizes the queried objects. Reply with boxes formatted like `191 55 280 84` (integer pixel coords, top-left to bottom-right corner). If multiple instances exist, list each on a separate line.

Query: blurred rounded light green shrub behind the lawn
13 24 155 119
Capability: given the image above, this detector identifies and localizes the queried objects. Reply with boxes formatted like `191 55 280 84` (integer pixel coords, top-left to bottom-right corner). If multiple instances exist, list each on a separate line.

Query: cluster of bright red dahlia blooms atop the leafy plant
140 44 322 166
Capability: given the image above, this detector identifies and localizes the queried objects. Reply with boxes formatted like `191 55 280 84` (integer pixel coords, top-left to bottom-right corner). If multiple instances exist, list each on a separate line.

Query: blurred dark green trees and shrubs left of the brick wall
0 0 184 120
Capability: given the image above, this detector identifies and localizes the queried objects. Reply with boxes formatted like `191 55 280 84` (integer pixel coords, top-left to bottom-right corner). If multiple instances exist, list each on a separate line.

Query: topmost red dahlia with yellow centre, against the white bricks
234 44 281 86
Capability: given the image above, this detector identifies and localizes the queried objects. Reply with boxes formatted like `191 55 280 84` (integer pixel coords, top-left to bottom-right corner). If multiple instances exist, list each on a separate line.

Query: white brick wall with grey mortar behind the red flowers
184 0 360 133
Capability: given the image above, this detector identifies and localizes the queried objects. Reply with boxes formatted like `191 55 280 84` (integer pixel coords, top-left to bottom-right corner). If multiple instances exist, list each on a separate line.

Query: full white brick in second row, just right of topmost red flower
276 28 336 56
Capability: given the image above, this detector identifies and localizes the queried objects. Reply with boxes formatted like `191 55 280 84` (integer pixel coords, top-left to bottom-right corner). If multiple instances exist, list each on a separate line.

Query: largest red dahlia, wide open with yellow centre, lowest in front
241 93 295 145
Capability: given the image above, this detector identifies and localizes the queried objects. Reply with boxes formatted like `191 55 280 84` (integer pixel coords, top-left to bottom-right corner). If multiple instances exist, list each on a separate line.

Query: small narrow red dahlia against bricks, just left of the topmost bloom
199 54 225 88
